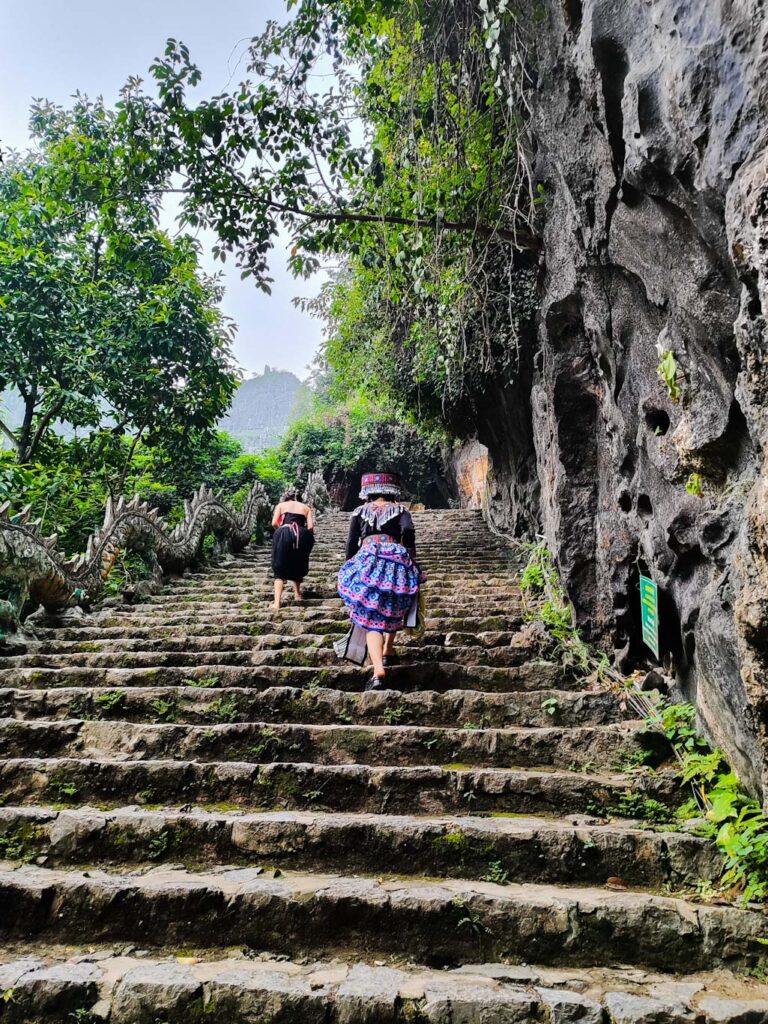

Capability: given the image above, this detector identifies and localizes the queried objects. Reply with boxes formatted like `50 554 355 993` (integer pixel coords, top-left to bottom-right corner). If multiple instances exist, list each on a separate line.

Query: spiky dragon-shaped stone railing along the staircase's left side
0 482 270 649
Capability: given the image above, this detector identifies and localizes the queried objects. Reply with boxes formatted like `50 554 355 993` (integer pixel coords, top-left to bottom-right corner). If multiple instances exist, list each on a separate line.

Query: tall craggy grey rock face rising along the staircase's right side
480 0 768 793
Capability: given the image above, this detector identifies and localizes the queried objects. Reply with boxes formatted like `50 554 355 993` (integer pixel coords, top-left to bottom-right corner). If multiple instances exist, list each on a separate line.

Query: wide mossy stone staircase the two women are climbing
0 511 768 1024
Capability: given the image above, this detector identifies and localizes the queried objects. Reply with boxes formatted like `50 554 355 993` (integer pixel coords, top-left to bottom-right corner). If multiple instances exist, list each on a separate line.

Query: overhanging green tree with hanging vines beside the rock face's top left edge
115 0 545 430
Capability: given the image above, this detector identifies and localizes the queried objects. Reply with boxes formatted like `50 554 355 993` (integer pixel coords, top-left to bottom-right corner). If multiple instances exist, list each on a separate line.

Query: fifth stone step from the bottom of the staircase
0 706 642 771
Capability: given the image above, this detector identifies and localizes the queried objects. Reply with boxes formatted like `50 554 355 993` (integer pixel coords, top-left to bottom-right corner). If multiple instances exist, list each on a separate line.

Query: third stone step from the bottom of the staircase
0 807 723 889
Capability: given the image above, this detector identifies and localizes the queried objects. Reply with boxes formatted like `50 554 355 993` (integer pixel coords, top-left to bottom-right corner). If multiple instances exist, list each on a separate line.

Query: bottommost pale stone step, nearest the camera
0 943 768 1024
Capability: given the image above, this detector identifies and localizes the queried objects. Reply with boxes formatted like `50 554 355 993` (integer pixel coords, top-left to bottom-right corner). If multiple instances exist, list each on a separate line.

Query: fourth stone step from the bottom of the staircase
0 758 685 815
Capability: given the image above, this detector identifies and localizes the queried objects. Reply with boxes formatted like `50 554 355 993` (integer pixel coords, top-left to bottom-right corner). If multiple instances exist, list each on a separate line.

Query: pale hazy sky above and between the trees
0 0 322 377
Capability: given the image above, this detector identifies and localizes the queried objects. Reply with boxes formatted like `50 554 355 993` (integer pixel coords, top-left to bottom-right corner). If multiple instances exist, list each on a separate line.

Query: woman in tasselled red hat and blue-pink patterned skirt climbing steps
339 473 421 690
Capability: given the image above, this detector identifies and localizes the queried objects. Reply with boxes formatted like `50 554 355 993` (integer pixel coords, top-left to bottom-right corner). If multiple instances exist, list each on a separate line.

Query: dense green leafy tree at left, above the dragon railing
0 97 237 468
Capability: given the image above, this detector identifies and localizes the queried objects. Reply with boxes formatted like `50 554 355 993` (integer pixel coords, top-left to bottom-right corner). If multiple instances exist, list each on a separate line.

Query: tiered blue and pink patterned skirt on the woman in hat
339 541 419 633
